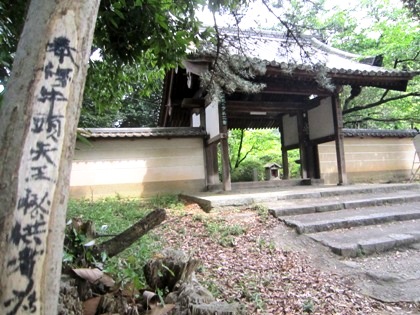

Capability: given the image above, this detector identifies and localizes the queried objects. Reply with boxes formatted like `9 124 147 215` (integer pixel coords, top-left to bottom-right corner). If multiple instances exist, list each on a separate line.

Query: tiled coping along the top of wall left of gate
78 127 207 138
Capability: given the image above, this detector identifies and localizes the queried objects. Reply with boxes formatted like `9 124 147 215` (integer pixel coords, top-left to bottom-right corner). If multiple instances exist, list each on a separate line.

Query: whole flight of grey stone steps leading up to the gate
264 184 420 257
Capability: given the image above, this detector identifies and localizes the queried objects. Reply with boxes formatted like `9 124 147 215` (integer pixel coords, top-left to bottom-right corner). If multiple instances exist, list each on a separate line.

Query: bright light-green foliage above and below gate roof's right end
266 0 420 129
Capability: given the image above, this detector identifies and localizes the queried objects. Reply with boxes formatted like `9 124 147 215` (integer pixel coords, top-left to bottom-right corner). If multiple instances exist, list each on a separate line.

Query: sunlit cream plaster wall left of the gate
70 138 205 197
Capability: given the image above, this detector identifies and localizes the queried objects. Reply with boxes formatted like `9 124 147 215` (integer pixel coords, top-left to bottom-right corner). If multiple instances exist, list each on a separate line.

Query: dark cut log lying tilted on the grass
94 209 166 257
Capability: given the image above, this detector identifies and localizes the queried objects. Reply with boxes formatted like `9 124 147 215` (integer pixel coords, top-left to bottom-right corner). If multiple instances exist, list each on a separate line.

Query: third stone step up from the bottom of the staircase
264 190 420 218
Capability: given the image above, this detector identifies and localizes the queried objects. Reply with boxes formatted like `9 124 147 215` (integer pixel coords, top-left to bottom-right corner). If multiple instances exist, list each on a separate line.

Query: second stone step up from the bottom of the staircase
279 202 420 234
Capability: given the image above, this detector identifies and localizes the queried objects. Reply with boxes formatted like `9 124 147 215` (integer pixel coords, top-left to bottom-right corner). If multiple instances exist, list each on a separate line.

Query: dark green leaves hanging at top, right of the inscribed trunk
94 0 208 69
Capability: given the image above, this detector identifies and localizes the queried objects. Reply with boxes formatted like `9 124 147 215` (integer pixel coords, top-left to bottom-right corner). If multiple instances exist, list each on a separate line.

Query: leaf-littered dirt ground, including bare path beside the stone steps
157 205 420 315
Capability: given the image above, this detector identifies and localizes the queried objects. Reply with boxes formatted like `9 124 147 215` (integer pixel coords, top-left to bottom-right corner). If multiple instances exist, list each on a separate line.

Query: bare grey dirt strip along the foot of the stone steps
270 222 420 314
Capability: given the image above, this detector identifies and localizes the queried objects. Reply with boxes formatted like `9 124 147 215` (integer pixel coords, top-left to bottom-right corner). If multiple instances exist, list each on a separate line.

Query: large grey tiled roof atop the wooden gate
193 30 420 78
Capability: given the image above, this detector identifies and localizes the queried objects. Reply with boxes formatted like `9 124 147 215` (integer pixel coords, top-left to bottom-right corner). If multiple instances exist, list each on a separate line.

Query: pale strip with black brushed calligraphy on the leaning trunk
2 36 78 314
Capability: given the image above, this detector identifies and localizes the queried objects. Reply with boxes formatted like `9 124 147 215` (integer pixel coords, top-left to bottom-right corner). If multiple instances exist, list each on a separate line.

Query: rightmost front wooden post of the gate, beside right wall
331 92 348 185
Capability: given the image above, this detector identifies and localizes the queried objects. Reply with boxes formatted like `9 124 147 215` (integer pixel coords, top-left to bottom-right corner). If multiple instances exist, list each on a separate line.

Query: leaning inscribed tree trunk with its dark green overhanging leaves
0 0 249 314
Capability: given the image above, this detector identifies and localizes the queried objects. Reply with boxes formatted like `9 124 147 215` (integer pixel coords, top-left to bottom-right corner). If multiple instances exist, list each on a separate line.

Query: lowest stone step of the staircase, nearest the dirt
307 220 420 257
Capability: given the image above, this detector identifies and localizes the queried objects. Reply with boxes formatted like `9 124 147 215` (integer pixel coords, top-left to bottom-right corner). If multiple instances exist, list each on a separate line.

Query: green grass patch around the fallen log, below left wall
67 195 182 288
